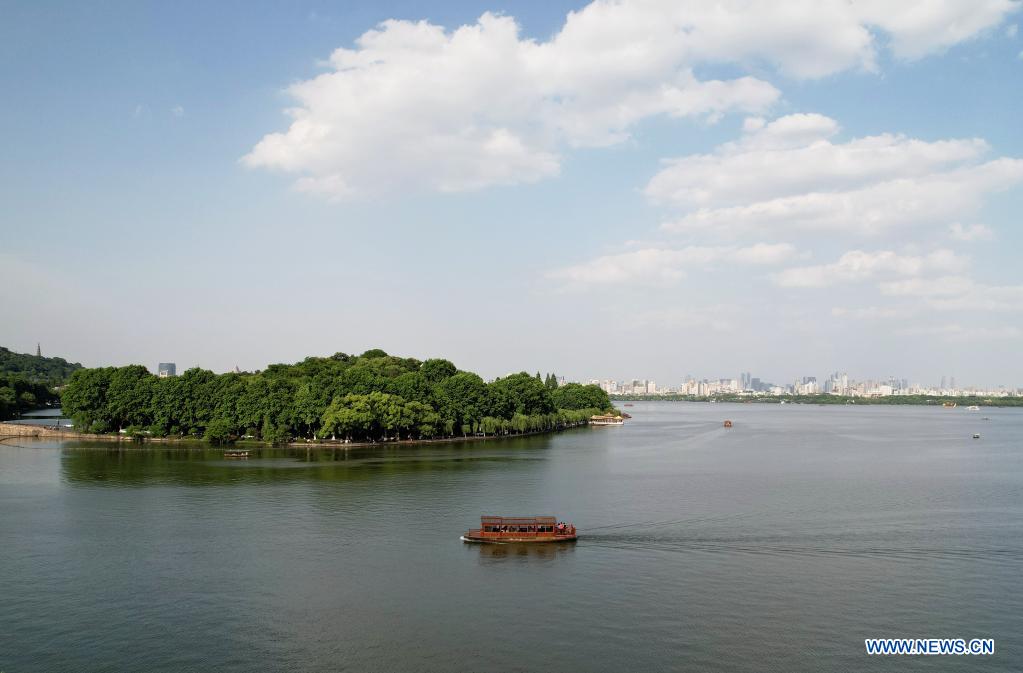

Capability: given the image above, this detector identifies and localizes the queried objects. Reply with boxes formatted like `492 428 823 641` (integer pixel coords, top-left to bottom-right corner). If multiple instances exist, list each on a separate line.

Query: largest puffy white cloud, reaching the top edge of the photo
242 0 1014 198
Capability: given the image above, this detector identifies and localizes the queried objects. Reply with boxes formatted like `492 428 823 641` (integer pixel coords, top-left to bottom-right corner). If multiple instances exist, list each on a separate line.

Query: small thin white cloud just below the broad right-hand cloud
773 250 968 287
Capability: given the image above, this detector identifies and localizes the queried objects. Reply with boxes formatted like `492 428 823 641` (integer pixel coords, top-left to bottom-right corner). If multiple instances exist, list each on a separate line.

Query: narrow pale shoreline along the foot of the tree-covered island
0 421 589 450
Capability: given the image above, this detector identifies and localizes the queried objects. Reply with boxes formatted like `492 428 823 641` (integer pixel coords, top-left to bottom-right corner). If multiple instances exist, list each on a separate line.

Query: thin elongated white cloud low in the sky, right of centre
548 243 799 285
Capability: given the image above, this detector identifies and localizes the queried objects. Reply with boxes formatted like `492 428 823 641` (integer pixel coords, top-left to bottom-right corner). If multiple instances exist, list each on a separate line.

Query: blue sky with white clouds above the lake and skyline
0 0 1023 388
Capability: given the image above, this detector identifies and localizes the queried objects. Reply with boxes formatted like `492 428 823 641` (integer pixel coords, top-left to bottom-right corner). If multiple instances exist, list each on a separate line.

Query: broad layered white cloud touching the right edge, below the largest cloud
646 114 1023 234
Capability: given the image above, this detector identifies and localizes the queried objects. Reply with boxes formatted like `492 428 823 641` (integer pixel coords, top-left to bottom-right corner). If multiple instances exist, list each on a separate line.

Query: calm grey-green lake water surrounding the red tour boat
0 403 1023 673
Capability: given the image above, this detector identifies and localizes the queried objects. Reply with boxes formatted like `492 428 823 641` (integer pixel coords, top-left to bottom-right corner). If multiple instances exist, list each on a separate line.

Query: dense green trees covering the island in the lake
61 349 612 443
